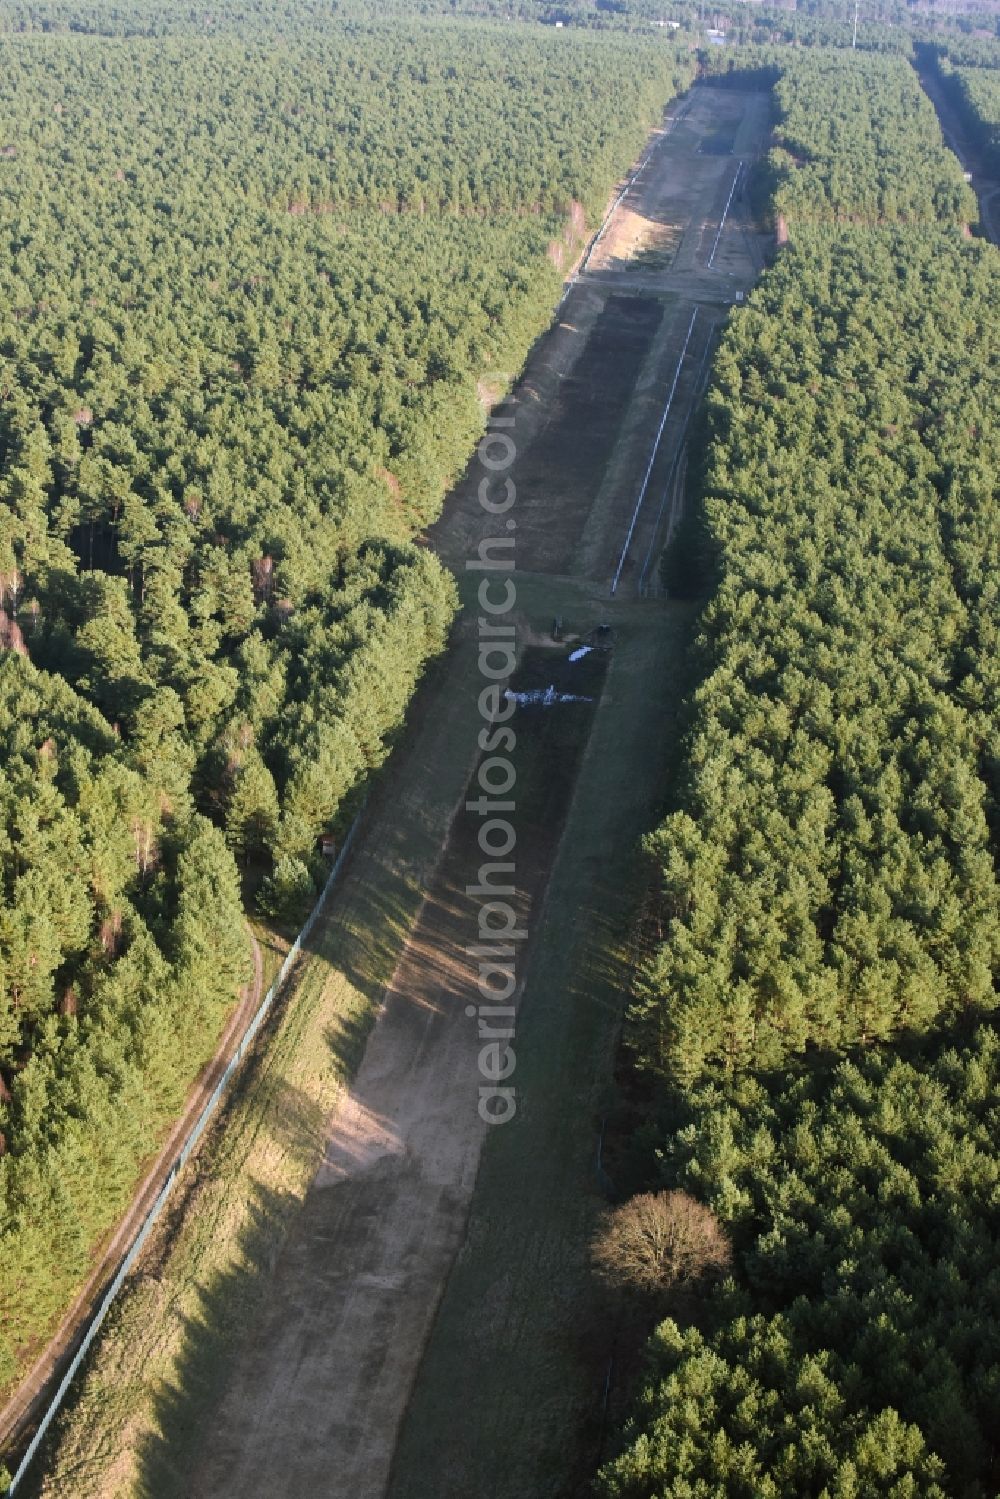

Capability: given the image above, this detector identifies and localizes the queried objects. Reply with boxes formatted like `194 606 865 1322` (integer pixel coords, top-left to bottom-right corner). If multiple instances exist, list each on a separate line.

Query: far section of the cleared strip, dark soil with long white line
430 87 769 597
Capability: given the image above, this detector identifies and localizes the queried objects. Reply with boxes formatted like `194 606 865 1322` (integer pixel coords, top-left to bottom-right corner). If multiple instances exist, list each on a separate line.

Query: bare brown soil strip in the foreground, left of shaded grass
193 859 494 1499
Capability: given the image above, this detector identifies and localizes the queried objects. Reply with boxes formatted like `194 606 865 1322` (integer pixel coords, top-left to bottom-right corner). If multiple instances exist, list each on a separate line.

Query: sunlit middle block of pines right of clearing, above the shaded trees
636 229 1000 1078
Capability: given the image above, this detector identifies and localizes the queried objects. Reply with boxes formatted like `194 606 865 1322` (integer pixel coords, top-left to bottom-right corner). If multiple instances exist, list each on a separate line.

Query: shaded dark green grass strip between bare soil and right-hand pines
390 579 693 1499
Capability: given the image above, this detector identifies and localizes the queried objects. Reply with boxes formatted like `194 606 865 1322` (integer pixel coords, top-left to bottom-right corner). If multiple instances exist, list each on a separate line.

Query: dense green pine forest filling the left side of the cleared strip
0 3 693 1382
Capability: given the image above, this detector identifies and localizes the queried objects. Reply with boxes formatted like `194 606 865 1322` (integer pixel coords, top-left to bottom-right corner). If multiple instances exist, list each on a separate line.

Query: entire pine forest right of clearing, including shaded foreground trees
597 54 1000 1499
